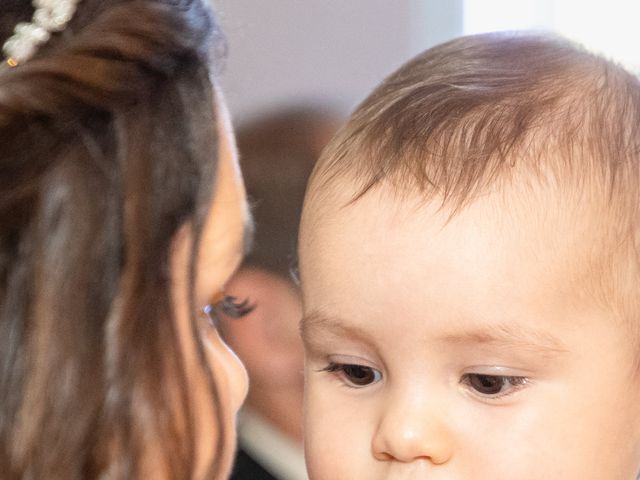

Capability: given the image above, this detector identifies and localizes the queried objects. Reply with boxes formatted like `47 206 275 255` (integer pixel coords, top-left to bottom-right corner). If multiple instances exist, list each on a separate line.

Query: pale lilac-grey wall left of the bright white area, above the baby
215 0 462 120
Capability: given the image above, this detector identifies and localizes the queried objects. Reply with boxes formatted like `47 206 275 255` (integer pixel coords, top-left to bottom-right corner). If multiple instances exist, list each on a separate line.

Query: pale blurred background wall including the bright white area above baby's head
214 0 640 122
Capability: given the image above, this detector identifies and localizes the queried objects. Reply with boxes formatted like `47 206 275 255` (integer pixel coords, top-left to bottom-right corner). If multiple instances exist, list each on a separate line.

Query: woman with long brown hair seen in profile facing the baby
0 0 247 479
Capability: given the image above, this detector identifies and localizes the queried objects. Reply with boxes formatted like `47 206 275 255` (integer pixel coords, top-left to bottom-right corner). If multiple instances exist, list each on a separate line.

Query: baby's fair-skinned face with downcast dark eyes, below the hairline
300 181 640 480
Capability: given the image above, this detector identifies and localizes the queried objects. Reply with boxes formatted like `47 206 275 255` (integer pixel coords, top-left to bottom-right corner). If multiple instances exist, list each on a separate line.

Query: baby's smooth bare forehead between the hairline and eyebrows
300 152 640 370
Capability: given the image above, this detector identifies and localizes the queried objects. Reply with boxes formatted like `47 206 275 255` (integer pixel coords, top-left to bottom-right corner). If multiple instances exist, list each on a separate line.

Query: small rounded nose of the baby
372 393 454 465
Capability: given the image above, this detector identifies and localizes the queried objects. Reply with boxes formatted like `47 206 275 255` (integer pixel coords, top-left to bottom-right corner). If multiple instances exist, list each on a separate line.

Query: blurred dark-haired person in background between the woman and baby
221 107 340 480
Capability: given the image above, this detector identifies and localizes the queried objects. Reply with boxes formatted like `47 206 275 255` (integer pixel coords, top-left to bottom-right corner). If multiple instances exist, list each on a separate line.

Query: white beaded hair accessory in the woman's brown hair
2 0 81 67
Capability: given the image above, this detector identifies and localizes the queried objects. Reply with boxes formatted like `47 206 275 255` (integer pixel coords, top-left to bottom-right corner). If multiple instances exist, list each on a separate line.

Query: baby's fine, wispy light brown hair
310 33 640 360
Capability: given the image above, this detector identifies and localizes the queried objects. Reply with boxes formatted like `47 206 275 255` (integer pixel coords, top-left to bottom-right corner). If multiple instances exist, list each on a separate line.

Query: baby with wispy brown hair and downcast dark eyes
300 34 640 480
